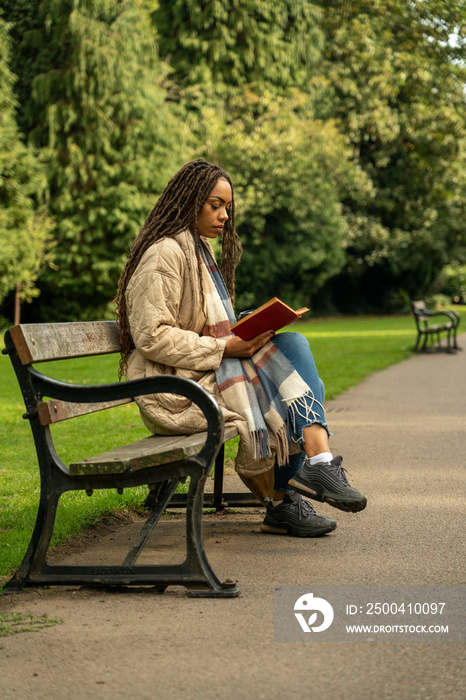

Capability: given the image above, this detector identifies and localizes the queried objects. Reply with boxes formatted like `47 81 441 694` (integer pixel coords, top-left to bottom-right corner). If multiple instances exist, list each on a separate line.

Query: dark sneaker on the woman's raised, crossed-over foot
288 455 367 513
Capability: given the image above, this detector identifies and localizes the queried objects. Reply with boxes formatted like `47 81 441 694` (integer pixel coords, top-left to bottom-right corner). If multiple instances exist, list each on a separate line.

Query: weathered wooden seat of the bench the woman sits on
69 425 238 476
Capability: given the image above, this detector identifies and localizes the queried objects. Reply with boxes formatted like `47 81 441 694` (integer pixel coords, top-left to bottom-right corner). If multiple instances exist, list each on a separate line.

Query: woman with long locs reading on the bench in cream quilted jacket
116 160 366 537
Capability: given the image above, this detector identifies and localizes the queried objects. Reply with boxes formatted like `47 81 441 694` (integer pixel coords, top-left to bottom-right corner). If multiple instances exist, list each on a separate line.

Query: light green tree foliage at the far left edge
0 19 52 315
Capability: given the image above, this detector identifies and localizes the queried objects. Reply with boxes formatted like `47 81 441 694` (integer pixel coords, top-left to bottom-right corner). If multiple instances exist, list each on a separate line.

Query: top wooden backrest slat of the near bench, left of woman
10 321 120 365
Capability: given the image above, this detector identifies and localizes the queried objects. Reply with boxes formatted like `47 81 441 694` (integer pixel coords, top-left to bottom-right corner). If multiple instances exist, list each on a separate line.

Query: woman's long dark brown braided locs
115 159 242 379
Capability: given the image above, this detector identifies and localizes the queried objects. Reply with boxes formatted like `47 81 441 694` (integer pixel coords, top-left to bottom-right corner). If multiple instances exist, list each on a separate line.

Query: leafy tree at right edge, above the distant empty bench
320 0 466 306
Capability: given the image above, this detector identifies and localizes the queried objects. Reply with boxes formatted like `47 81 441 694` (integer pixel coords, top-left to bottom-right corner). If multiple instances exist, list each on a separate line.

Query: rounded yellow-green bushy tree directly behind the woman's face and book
204 95 368 309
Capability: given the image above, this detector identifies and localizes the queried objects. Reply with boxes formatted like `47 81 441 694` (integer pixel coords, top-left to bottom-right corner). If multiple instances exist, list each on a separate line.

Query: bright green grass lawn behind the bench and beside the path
0 309 466 577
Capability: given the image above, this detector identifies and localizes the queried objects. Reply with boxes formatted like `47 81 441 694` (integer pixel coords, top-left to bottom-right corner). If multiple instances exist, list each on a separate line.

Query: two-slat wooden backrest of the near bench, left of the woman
5 321 133 426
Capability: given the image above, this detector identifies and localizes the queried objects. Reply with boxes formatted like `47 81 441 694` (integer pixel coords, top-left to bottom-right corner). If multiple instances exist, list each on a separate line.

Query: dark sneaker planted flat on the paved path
261 494 337 537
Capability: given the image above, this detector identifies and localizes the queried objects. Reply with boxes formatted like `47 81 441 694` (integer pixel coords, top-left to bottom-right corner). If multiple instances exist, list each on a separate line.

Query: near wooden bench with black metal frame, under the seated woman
3 321 260 597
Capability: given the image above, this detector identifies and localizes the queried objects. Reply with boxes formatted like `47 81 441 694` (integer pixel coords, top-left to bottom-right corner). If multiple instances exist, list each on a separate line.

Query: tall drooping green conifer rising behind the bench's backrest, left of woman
3 0 183 318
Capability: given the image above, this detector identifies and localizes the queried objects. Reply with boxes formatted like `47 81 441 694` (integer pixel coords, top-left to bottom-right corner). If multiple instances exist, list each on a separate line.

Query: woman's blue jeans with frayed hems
272 333 330 491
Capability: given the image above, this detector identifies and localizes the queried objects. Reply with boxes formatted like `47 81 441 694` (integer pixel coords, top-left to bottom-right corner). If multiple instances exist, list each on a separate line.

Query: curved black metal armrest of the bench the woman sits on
28 367 224 469
